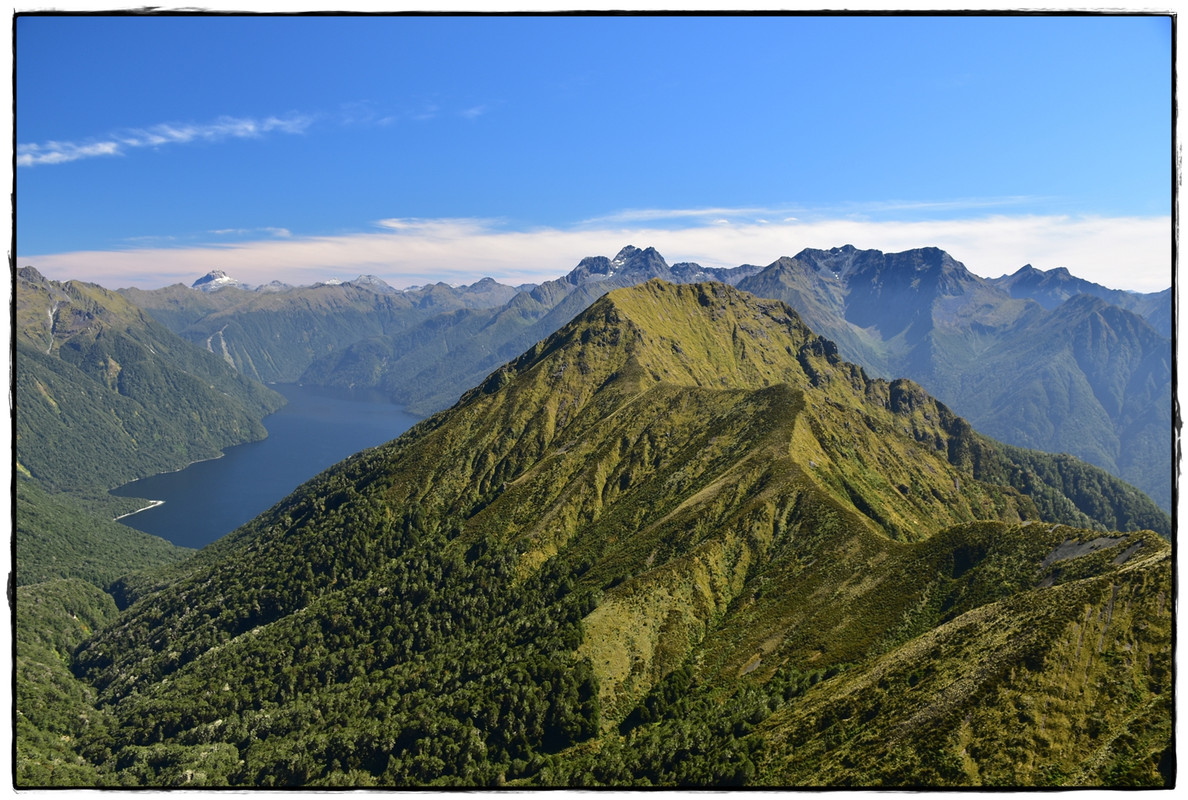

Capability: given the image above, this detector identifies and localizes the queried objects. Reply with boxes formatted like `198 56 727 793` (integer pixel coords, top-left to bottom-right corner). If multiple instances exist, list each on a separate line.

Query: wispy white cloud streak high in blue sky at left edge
17 114 314 166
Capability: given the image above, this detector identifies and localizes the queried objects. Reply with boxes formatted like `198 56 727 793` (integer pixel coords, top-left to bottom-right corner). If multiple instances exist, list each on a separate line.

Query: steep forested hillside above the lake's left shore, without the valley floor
15 267 284 493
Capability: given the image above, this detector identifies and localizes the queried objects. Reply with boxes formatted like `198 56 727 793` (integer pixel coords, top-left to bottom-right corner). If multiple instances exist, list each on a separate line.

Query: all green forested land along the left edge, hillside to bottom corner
11 267 283 786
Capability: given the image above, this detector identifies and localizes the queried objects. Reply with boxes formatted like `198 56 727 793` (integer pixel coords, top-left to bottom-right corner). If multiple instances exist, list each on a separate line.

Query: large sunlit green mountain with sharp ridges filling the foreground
23 282 1171 787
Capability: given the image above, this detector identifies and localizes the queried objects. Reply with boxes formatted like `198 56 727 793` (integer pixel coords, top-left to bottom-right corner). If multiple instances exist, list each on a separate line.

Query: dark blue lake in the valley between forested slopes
112 384 419 547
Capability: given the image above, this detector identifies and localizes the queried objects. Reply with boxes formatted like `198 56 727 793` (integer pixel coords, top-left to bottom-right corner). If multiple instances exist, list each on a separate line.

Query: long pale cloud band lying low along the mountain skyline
18 215 1171 291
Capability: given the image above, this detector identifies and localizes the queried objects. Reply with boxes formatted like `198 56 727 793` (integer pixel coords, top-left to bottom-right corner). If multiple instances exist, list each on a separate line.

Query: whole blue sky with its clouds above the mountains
14 10 1173 291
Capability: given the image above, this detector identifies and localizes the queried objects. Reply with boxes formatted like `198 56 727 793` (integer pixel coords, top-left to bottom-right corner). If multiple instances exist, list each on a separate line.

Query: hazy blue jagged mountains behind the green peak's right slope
739 245 1173 510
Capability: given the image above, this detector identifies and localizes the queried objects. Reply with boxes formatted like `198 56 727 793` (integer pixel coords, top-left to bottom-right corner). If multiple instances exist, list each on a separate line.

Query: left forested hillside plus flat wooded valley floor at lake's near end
13 267 283 613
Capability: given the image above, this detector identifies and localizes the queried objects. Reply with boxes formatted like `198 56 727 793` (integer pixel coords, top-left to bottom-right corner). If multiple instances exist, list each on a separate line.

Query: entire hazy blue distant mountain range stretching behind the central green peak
118 240 1171 510
